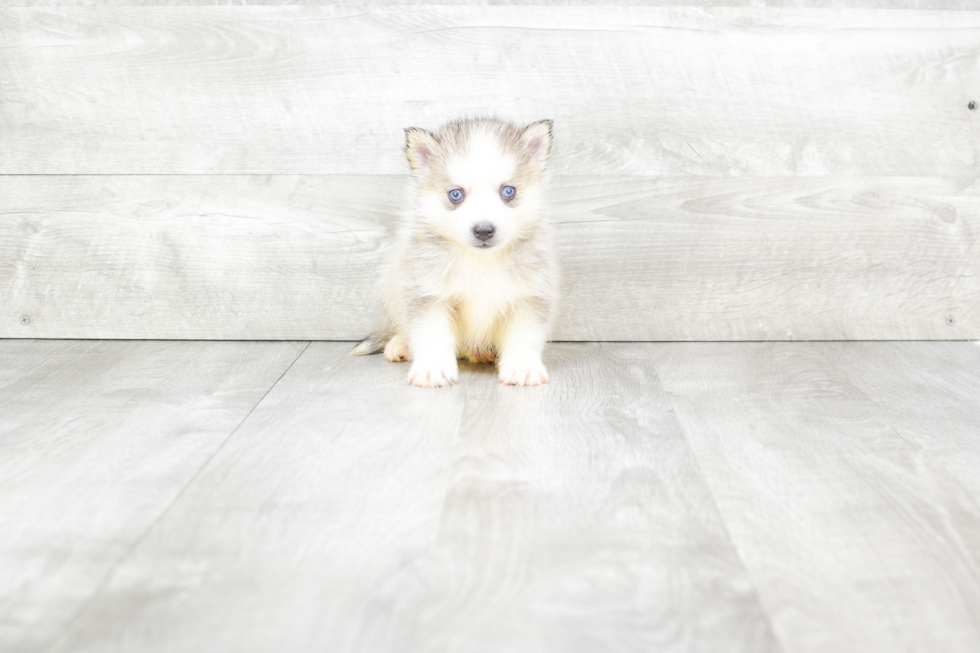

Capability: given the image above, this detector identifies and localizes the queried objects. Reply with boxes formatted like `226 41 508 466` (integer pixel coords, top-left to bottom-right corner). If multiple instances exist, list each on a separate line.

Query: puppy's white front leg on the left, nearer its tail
408 304 459 388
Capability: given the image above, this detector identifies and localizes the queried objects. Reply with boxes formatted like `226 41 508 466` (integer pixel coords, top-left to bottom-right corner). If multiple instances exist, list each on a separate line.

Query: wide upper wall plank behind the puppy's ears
0 6 980 176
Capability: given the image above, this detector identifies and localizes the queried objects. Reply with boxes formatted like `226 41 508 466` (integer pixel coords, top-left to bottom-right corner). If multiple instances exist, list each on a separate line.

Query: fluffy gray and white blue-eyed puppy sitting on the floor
351 118 558 387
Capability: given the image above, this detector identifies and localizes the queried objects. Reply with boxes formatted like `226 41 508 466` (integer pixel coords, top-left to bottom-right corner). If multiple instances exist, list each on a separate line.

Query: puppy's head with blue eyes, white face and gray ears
405 118 551 253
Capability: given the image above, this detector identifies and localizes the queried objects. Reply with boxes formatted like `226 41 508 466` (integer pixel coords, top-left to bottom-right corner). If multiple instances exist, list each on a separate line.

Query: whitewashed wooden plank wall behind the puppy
0 0 980 340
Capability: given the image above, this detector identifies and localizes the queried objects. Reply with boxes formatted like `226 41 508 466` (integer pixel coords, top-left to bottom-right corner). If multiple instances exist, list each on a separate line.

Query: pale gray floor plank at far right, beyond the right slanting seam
652 343 980 653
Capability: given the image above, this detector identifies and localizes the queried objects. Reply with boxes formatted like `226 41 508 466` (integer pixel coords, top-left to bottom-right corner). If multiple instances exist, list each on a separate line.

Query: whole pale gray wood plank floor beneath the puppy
0 340 980 653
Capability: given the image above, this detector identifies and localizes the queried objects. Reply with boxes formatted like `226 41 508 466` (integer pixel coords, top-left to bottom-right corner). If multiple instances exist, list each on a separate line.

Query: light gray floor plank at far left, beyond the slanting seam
0 340 304 653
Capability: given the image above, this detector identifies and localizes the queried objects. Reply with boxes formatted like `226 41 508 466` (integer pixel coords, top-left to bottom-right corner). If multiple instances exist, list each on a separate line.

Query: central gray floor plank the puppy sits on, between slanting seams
47 343 778 653
